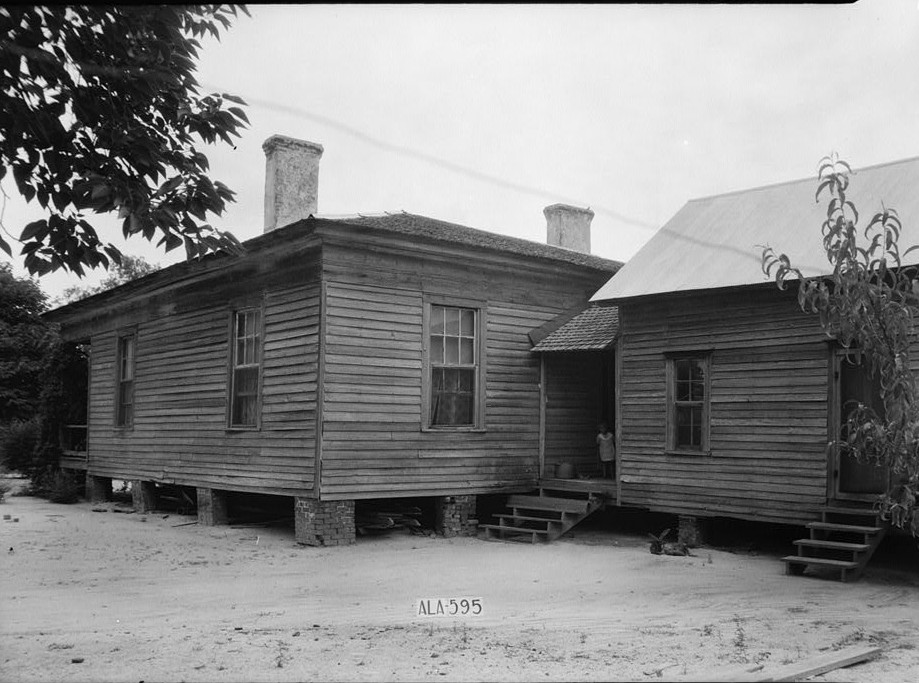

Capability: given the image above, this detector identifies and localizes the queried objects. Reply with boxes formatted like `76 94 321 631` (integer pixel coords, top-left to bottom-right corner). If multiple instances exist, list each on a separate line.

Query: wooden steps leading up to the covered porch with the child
479 480 604 543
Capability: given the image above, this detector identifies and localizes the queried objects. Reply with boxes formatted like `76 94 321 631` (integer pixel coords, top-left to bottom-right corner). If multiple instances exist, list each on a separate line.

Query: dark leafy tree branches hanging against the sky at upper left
0 5 248 275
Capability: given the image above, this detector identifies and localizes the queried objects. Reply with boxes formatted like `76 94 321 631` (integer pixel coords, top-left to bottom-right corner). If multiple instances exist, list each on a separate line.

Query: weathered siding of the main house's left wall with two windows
83 276 319 495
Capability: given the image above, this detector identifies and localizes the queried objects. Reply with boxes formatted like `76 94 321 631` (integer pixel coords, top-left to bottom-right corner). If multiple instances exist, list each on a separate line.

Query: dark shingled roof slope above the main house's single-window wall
316 211 622 272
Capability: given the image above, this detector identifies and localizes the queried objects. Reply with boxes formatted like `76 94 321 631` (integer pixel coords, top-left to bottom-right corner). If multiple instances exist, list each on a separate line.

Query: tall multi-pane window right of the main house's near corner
427 305 481 427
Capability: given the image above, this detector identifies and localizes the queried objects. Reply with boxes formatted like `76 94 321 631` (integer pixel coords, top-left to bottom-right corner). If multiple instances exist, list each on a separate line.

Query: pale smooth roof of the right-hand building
591 157 919 301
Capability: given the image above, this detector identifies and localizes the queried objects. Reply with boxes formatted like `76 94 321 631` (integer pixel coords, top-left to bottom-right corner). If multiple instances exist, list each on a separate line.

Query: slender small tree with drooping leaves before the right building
762 156 919 535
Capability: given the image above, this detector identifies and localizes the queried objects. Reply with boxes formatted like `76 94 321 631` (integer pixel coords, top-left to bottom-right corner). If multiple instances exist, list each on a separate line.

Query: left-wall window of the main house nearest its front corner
230 308 261 427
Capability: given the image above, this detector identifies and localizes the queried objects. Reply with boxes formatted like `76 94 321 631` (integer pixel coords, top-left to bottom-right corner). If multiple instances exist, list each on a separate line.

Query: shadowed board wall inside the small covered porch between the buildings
545 353 612 477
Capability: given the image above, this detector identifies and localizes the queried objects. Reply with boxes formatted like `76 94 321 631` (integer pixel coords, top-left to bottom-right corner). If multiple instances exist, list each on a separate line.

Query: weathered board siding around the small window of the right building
620 287 829 523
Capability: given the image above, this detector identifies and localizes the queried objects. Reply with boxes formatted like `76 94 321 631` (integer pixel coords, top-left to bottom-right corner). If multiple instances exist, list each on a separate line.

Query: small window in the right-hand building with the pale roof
667 355 710 452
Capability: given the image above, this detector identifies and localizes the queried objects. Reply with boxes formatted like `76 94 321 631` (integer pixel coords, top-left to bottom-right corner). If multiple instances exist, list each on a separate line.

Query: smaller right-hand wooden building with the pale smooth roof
592 159 919 580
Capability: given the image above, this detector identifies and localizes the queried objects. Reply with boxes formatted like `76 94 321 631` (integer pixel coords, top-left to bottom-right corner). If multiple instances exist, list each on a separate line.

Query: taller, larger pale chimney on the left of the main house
262 135 323 232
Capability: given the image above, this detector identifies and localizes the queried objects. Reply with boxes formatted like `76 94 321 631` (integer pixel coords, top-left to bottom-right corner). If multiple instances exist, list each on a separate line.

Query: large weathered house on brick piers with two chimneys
48 136 620 545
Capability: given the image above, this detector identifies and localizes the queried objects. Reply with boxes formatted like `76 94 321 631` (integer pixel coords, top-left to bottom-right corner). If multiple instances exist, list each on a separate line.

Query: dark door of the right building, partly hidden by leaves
830 350 889 500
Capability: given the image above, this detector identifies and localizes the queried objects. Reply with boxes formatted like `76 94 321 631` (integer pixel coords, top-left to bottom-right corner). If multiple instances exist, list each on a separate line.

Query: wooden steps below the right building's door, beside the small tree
782 505 887 581
